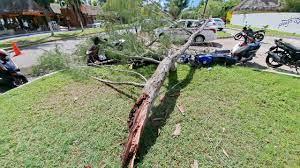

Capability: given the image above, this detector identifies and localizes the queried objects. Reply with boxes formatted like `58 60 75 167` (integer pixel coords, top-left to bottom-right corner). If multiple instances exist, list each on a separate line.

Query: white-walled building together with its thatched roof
231 0 300 34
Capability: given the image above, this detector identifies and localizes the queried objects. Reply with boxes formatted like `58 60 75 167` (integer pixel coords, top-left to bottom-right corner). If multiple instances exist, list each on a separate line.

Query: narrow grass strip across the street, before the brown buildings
0 28 104 48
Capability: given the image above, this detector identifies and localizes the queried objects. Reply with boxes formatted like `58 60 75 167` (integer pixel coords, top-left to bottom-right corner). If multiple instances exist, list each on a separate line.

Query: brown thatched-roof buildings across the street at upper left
0 0 99 35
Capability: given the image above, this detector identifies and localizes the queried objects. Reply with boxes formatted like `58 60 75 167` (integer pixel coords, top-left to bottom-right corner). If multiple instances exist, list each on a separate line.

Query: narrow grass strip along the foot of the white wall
226 24 300 37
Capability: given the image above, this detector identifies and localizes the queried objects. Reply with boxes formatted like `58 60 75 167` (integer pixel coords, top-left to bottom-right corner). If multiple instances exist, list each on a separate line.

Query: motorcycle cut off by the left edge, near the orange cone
0 49 28 87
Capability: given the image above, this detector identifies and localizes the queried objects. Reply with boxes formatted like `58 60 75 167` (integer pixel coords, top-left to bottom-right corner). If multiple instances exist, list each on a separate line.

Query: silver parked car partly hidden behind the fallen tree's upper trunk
154 19 217 43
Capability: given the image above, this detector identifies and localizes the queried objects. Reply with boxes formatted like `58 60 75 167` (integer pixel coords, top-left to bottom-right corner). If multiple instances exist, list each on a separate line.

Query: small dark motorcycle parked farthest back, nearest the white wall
234 26 267 42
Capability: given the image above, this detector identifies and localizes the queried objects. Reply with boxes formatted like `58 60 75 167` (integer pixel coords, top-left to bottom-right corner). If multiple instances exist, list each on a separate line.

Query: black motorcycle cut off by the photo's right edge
266 39 300 71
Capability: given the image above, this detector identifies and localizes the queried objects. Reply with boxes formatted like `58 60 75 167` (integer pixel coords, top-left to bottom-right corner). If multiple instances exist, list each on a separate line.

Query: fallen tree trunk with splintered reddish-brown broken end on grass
122 20 208 167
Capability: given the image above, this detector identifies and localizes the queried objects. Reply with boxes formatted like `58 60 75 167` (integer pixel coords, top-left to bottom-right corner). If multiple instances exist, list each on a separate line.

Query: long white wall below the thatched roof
231 13 300 34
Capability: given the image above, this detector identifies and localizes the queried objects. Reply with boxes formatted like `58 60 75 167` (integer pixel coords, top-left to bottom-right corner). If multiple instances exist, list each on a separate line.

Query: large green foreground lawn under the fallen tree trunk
0 66 300 167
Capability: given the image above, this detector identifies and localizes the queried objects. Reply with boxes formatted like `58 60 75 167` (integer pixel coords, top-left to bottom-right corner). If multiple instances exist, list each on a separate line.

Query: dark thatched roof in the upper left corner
0 0 43 15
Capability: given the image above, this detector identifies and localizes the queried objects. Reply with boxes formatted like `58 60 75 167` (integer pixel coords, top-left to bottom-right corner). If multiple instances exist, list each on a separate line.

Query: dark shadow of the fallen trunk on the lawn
136 67 196 163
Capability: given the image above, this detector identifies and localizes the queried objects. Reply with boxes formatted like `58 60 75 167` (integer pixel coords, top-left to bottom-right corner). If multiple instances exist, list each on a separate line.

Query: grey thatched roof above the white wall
233 0 283 11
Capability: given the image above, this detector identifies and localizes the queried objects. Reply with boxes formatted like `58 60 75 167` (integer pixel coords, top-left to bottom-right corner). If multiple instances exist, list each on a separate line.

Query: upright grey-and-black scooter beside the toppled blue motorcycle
231 32 261 63
